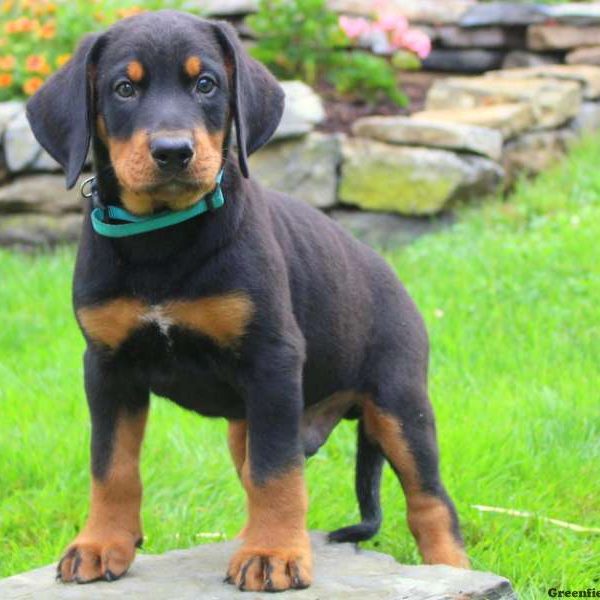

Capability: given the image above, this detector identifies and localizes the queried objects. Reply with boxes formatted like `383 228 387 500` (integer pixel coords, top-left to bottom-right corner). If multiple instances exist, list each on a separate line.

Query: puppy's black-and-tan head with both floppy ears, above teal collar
27 11 283 214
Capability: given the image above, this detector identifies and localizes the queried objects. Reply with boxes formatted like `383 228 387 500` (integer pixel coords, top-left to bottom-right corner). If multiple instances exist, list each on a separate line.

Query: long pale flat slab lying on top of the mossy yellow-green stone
352 116 502 160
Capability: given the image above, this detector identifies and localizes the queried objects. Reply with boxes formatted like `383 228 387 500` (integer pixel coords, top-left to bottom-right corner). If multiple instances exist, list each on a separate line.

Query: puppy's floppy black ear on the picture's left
27 34 102 189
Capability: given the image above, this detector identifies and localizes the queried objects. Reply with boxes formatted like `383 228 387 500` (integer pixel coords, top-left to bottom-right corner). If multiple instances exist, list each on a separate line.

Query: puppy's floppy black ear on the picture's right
215 22 285 177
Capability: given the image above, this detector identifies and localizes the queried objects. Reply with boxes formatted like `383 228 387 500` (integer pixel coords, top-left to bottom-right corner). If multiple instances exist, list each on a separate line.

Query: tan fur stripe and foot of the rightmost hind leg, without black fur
363 399 469 568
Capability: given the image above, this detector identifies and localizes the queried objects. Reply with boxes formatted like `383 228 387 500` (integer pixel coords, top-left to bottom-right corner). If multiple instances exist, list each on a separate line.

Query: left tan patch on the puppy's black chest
77 298 145 349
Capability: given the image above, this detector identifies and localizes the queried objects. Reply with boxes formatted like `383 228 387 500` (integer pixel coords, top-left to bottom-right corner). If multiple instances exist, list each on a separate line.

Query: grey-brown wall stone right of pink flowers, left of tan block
436 25 525 48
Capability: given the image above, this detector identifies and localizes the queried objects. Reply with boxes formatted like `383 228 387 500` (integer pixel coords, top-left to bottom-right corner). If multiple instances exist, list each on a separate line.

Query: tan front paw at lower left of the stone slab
56 533 141 583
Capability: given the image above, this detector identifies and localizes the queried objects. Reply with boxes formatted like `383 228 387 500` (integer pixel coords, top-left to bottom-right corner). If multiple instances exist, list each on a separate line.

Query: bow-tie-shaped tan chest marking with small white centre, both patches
77 292 254 351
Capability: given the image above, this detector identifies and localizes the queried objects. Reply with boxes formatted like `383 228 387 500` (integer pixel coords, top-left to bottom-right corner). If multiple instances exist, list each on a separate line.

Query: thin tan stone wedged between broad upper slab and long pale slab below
411 102 535 140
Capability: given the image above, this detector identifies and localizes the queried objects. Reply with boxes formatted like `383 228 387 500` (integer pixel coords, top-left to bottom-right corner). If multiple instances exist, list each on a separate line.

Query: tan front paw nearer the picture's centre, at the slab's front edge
225 547 312 592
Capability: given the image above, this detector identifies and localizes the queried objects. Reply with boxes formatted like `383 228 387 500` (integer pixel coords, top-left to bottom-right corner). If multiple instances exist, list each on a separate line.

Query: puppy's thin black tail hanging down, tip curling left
328 420 384 543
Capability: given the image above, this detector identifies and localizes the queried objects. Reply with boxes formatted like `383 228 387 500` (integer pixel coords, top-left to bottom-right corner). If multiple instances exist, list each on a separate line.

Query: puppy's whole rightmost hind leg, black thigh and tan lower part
363 378 469 567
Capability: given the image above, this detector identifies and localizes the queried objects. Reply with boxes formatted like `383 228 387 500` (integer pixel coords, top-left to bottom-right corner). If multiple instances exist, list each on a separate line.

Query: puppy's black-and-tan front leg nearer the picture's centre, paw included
227 350 312 591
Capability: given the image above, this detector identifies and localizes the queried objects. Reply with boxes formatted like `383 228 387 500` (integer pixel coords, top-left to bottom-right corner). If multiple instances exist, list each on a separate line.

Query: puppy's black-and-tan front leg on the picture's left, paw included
58 350 148 583
